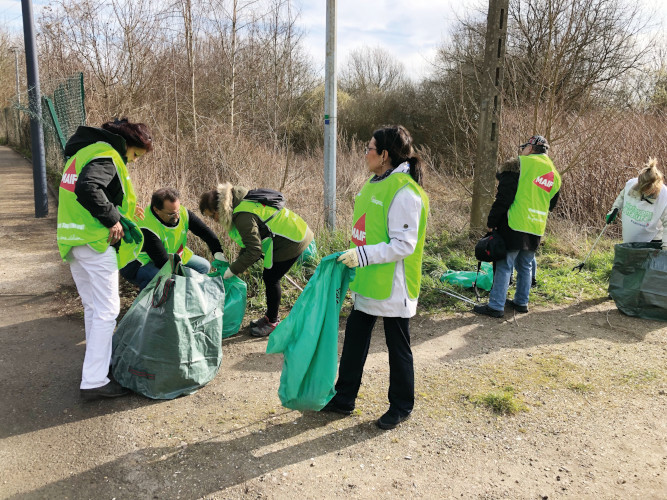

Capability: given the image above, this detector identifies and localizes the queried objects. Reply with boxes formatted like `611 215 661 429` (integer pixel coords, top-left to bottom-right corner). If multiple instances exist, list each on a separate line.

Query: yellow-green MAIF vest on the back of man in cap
507 154 560 236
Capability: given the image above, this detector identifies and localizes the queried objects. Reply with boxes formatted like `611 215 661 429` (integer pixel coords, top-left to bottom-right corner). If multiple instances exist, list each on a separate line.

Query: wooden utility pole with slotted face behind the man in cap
470 0 509 235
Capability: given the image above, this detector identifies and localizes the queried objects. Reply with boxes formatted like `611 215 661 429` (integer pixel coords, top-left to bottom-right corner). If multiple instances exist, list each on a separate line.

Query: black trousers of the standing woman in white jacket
334 310 415 415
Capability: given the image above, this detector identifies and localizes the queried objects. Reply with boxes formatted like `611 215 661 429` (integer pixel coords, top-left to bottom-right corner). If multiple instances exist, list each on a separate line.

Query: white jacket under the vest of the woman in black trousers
353 162 422 318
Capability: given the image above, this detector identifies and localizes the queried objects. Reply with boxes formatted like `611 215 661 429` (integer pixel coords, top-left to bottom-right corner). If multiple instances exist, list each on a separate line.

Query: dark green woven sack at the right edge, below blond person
609 242 667 321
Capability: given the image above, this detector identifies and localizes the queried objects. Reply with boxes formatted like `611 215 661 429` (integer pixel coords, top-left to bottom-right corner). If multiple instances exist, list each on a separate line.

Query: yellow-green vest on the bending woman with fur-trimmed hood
229 200 308 269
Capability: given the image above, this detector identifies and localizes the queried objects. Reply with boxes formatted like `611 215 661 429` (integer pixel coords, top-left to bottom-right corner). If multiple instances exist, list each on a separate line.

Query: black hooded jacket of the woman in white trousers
65 126 127 227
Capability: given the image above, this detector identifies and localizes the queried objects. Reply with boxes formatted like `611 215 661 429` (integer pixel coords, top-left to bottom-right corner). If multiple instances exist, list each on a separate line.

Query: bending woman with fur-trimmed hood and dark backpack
199 183 313 337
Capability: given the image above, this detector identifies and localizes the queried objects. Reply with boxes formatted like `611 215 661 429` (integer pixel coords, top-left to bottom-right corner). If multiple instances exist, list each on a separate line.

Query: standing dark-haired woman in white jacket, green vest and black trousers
323 125 429 429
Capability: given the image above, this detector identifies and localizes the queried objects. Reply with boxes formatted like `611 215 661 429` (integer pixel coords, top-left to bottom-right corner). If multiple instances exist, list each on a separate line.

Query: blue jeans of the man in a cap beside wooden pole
489 250 535 311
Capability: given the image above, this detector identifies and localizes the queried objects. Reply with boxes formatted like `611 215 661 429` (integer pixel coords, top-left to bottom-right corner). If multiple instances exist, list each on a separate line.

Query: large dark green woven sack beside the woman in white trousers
111 260 225 399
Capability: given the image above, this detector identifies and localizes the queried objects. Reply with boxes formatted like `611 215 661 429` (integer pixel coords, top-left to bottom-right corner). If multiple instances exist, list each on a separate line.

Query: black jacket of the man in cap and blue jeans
486 158 560 251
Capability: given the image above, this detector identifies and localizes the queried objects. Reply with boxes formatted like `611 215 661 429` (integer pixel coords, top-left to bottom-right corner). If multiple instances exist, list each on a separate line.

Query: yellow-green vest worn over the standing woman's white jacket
350 173 429 300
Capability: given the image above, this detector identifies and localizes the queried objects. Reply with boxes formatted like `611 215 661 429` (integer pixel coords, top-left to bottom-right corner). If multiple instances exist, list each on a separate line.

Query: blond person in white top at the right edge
606 158 667 250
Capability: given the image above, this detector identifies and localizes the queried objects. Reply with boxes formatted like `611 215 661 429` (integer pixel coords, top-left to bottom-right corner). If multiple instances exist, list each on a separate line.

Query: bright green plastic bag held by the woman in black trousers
266 253 354 411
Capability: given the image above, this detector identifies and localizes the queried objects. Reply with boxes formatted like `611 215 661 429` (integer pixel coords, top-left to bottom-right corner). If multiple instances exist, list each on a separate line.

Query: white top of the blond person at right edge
611 177 667 249
